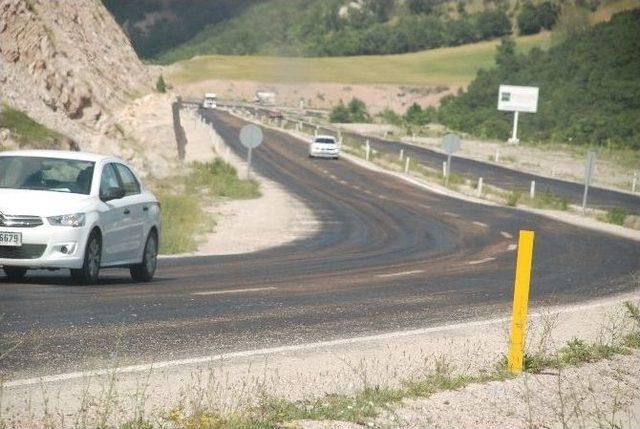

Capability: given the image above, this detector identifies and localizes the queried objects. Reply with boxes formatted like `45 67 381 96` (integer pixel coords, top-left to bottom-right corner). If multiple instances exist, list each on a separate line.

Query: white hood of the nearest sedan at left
0 189 93 216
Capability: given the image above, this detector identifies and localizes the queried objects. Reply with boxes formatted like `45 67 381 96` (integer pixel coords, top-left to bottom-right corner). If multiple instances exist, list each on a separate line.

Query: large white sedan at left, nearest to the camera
0 150 161 284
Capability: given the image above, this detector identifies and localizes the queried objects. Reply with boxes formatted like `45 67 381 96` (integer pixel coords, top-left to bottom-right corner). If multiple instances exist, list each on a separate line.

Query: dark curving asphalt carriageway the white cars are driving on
0 112 640 379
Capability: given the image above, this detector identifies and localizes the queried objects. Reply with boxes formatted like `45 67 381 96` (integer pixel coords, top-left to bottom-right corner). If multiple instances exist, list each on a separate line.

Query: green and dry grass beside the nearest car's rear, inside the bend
152 159 260 255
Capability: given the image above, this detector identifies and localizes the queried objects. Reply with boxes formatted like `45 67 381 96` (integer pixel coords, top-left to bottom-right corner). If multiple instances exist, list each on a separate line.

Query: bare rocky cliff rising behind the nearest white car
0 0 152 154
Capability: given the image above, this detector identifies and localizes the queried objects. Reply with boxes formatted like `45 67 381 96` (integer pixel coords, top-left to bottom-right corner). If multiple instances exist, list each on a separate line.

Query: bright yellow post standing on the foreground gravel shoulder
508 231 534 374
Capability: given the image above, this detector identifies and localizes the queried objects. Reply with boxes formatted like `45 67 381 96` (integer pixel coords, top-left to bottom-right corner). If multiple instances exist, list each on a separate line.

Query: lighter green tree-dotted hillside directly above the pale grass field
158 0 512 63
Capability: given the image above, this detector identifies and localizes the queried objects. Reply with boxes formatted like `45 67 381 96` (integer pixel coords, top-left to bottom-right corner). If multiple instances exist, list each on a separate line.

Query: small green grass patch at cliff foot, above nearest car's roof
0 104 63 149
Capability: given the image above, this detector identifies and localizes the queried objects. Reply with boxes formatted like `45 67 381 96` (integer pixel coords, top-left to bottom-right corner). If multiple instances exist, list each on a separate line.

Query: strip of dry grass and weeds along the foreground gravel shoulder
8 302 640 429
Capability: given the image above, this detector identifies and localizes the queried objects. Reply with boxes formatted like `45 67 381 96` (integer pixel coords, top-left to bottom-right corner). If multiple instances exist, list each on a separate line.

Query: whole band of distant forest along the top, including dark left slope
103 0 602 63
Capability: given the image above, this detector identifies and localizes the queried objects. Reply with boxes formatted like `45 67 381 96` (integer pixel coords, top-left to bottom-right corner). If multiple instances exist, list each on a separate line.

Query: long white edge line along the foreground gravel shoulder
3 296 629 388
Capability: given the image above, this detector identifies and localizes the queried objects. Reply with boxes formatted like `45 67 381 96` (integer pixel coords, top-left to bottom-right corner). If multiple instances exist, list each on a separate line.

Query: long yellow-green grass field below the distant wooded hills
169 34 550 86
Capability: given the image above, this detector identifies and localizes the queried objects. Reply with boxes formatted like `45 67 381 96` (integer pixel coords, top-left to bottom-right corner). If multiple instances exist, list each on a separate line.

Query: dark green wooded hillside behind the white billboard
439 9 640 150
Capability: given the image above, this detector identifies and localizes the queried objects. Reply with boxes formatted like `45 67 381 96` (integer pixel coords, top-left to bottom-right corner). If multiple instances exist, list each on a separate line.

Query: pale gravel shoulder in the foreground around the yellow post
2 293 640 427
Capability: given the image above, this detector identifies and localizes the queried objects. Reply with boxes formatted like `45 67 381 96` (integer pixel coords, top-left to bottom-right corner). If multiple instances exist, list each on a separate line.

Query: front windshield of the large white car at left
0 156 94 195
